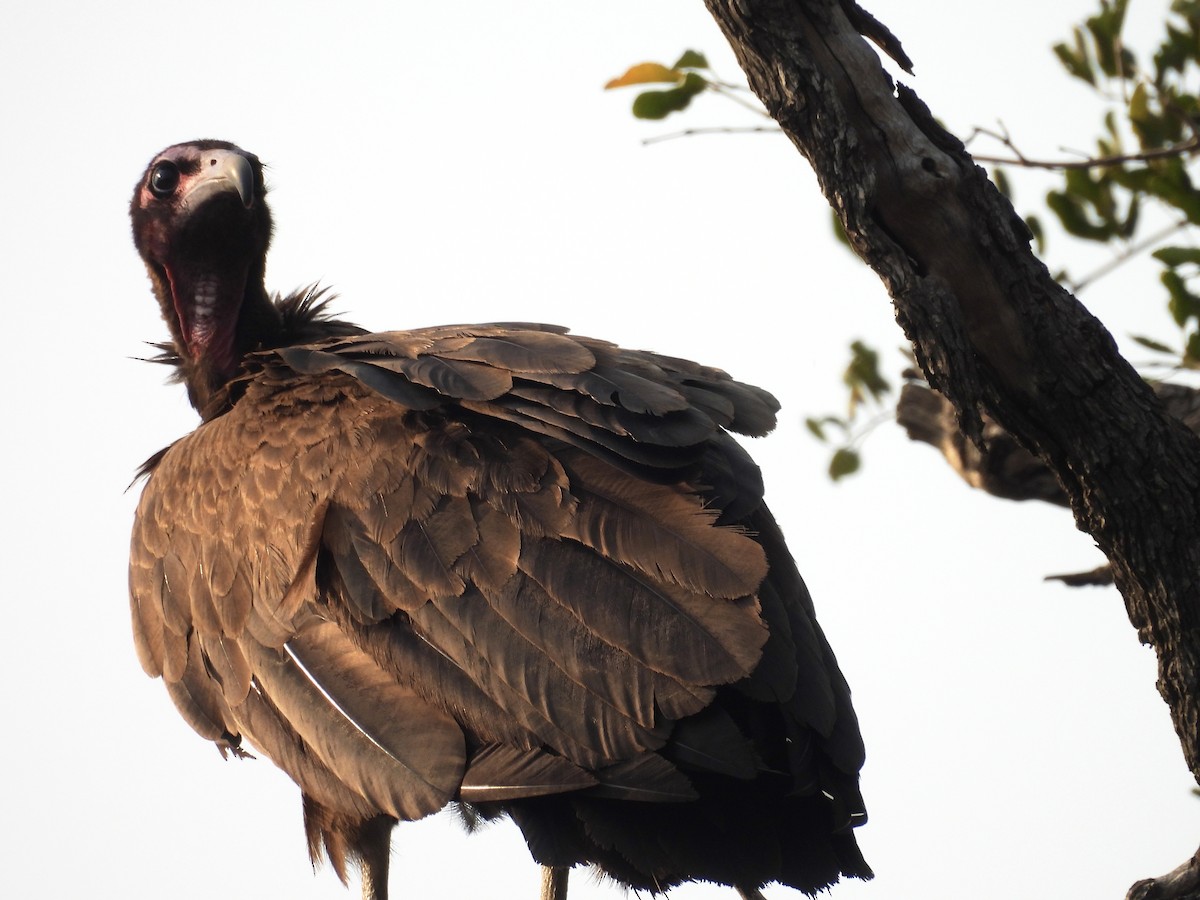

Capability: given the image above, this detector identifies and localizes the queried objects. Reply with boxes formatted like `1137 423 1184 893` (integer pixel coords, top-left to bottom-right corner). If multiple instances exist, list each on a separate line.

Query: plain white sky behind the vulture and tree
0 0 1200 900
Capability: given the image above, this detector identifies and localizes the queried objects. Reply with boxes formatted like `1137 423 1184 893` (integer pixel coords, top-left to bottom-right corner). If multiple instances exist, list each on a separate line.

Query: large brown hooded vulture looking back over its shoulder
130 140 871 900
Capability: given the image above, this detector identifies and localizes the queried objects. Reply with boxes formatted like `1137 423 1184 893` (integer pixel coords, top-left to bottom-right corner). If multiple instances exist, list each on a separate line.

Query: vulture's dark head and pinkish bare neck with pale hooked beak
130 140 282 410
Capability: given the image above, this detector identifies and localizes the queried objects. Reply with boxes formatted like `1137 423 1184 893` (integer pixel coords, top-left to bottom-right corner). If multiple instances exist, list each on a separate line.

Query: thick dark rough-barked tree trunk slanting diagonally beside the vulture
706 0 1200 883
